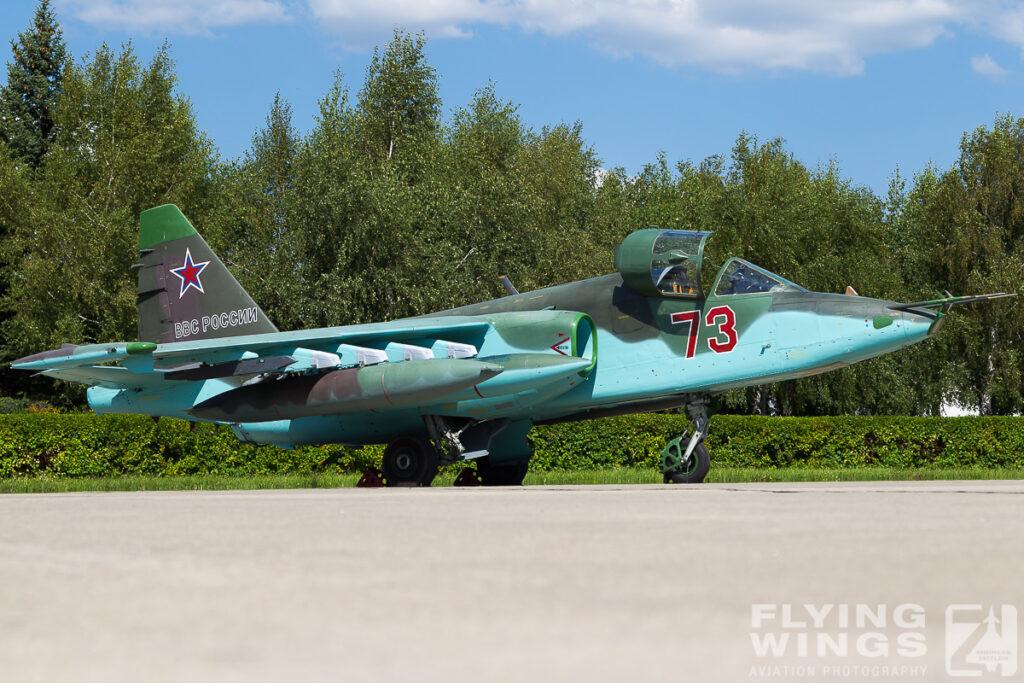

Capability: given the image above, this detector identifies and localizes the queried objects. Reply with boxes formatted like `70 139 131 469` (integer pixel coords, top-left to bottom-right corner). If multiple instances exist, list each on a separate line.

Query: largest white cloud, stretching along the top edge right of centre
309 0 967 74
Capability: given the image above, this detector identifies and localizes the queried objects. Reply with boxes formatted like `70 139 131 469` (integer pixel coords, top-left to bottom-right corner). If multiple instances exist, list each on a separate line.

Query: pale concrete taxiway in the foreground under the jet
0 481 1024 681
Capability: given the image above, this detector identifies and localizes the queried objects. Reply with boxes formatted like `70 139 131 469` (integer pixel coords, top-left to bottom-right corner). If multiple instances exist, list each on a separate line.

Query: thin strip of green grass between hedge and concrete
0 467 1024 494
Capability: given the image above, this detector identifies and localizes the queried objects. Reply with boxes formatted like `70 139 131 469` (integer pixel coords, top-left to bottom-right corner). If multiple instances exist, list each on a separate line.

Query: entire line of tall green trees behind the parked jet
0 0 1024 415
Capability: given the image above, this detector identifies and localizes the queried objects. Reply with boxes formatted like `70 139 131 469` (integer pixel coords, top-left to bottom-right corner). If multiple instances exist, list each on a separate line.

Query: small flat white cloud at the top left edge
59 0 289 34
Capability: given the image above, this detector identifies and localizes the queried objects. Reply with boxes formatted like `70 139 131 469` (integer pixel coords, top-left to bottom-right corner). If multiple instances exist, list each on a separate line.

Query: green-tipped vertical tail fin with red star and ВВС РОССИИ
134 204 278 343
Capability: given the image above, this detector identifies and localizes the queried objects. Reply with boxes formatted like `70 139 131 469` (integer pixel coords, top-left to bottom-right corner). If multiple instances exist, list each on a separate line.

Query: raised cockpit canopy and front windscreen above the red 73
615 227 806 299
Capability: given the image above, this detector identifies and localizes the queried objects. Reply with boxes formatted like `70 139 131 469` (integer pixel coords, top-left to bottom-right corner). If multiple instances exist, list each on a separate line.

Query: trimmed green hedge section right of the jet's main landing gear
530 415 1024 470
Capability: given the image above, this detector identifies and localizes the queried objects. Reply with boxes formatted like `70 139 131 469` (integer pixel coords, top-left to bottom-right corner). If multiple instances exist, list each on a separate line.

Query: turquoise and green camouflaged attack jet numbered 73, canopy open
12 205 1012 485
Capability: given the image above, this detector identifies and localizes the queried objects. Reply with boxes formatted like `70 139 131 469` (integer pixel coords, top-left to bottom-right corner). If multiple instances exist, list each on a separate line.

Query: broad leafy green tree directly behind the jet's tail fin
0 44 221 385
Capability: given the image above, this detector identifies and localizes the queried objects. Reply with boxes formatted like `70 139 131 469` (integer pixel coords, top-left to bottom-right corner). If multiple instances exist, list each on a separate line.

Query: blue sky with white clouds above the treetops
0 0 1024 194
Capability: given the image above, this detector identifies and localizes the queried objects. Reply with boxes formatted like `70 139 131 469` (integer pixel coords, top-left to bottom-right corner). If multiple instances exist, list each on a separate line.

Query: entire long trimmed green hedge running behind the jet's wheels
0 414 1024 478
